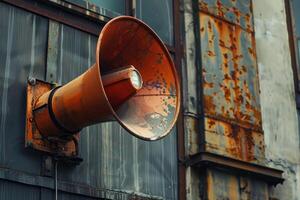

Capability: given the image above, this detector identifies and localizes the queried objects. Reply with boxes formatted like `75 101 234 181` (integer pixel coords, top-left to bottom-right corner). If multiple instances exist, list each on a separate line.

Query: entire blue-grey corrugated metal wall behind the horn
0 3 177 199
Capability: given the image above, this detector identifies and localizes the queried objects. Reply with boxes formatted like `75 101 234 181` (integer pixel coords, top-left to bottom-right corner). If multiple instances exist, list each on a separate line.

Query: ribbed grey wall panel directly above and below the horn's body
48 25 177 199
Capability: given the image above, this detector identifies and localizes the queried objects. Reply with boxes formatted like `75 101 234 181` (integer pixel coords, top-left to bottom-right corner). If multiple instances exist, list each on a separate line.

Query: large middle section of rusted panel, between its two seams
200 13 261 129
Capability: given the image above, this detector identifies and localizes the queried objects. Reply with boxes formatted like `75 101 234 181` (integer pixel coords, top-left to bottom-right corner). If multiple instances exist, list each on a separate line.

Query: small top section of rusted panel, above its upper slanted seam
199 0 253 32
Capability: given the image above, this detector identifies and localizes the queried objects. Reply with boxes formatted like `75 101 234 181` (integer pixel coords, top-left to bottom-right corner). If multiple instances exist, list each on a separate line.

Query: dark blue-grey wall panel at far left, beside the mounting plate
0 3 48 174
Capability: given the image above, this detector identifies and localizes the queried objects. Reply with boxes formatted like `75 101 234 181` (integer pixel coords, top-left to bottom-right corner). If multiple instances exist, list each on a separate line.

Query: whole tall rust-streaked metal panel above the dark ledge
198 0 264 164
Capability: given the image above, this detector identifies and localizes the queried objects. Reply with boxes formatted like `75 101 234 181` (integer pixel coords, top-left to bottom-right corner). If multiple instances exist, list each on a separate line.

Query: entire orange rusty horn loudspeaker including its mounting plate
26 16 180 159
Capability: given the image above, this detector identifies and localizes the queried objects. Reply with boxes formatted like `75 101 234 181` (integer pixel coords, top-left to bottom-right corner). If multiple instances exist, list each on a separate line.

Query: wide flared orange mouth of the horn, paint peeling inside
96 16 180 141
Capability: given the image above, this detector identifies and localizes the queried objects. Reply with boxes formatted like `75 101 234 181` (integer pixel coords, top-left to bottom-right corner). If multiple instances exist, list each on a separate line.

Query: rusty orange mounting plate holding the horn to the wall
25 78 82 163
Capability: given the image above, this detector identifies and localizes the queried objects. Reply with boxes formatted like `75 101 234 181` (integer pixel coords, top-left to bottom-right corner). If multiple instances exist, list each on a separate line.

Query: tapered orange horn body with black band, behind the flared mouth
34 65 112 136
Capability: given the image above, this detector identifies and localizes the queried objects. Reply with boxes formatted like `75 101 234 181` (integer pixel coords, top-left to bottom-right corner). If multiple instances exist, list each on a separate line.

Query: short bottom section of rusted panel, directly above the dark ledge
205 118 265 163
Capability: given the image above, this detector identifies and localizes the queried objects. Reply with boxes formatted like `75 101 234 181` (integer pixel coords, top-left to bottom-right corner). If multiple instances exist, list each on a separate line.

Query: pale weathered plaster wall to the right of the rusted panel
253 0 300 200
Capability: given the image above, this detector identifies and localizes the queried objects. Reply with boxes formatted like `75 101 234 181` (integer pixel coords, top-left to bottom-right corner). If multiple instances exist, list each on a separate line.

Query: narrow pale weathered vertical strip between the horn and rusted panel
182 0 200 200
